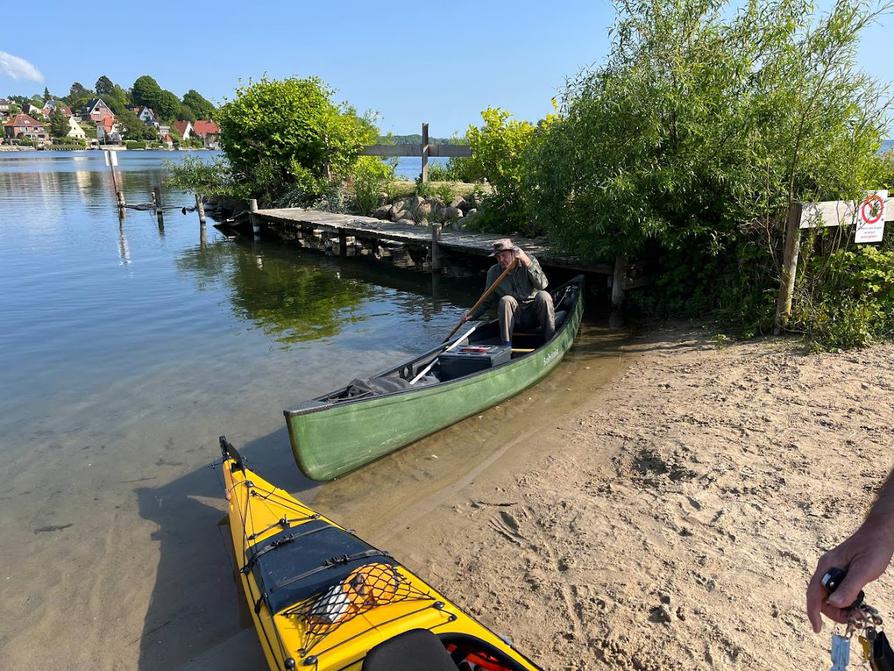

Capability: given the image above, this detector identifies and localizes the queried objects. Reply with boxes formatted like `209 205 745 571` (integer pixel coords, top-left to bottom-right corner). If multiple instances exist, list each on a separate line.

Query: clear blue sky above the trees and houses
0 0 894 137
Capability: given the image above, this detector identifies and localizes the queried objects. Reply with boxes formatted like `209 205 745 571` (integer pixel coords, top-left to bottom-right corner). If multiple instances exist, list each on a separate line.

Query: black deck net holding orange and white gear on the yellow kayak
280 563 434 655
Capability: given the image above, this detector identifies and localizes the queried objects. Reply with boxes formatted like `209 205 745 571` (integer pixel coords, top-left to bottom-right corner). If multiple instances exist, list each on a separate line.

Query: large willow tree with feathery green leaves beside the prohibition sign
526 0 887 336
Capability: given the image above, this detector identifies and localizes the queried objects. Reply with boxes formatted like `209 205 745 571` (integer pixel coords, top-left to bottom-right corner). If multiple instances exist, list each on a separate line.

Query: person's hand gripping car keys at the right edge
807 520 894 634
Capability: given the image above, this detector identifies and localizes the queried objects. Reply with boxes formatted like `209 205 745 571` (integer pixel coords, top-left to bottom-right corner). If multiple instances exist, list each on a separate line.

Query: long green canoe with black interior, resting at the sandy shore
284 275 584 480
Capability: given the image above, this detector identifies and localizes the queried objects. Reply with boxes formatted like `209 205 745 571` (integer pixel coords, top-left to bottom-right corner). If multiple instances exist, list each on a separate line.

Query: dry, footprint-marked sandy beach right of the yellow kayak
364 325 894 670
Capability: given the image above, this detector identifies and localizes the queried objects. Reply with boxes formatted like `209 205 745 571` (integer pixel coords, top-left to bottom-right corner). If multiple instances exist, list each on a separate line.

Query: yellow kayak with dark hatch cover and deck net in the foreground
220 437 541 671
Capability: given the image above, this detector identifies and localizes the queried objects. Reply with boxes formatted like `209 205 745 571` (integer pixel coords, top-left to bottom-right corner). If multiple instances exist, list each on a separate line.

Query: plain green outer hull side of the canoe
285 276 583 480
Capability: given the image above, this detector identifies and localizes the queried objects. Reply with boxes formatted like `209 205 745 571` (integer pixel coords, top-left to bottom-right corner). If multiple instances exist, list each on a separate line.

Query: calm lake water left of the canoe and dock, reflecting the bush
0 152 479 669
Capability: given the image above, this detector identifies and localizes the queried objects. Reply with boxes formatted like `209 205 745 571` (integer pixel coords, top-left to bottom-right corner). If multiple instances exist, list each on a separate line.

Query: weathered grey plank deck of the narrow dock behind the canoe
255 208 614 276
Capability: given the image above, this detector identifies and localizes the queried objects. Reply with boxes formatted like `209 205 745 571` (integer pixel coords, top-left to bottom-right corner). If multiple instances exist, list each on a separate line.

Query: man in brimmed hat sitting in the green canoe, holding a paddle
463 238 556 345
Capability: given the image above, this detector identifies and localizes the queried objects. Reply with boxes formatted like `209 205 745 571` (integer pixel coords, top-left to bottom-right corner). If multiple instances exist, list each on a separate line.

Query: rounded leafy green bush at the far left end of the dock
218 77 378 202
